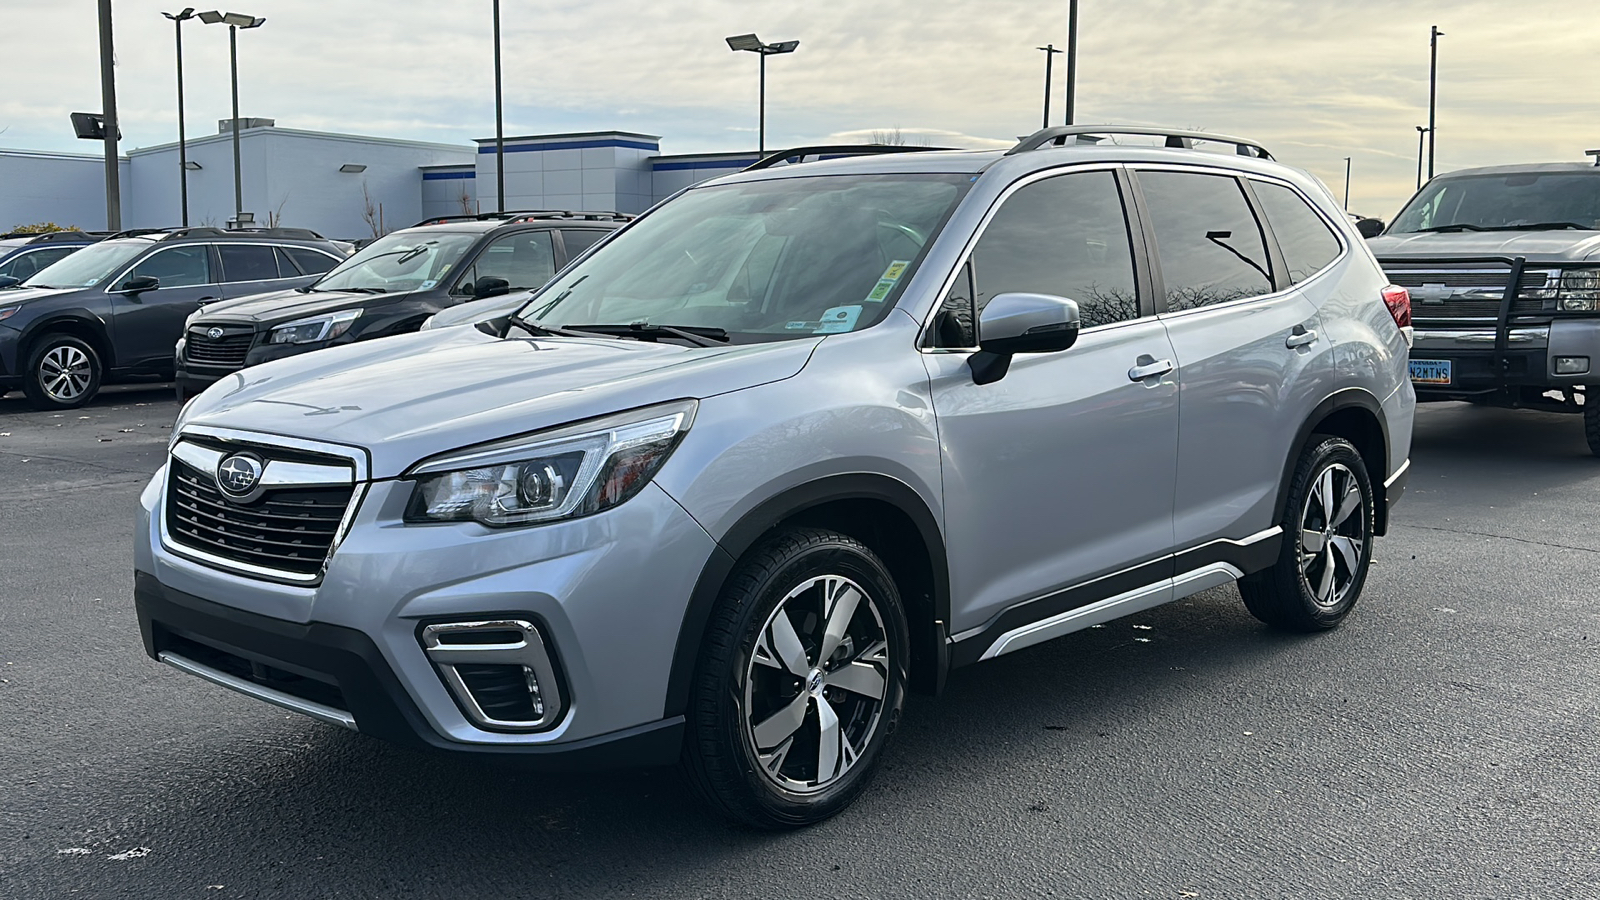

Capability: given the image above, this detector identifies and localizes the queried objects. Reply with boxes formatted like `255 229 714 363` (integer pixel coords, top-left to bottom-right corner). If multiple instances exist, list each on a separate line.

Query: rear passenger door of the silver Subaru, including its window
1136 167 1331 550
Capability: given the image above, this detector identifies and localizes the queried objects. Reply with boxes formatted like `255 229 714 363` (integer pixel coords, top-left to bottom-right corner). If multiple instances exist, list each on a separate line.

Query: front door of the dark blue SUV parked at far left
109 243 221 370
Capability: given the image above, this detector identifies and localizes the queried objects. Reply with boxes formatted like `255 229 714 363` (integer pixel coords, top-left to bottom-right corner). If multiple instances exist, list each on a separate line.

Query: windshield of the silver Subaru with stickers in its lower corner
520 175 970 341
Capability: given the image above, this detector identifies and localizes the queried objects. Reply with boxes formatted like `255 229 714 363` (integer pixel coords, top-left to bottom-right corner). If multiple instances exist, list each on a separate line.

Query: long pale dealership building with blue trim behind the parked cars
0 119 757 239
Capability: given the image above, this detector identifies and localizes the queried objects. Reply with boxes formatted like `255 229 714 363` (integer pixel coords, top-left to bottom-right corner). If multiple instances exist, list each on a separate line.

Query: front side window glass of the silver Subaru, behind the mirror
973 171 1139 328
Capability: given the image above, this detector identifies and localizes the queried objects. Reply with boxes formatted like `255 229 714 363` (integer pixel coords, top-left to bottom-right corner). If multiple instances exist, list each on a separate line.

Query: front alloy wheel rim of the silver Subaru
742 575 890 793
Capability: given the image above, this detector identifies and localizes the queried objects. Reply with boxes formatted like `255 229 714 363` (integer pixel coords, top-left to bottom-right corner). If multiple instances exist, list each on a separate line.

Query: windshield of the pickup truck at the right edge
1389 168 1600 234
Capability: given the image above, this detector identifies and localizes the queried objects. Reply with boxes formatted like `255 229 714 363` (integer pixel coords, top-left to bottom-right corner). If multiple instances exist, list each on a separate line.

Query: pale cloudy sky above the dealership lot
0 0 1600 218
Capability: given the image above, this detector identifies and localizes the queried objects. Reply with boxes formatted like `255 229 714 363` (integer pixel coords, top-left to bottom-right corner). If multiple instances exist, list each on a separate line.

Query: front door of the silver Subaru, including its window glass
923 170 1178 634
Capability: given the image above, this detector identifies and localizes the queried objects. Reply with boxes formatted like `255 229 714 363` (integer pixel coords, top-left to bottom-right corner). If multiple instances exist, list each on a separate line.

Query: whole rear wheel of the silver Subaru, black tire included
1238 434 1374 631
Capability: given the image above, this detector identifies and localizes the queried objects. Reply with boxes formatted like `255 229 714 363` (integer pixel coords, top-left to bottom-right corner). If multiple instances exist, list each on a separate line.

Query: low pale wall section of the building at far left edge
0 151 133 232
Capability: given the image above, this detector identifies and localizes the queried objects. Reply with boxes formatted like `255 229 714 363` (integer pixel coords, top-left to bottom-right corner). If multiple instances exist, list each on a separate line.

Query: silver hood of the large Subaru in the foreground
178 328 822 479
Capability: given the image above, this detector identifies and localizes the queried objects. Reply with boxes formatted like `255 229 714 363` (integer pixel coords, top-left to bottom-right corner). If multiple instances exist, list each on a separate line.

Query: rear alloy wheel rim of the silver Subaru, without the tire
1299 463 1366 609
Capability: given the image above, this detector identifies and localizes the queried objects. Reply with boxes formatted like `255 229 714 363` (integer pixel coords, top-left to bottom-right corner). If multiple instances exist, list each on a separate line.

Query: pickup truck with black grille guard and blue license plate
1368 151 1600 456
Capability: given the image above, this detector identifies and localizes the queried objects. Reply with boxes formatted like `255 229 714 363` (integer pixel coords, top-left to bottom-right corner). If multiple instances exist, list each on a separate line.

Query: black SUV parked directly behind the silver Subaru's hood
176 210 632 399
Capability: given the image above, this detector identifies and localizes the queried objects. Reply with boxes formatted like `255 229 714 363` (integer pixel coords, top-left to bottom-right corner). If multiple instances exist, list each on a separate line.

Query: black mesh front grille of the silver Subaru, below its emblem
166 458 355 577
